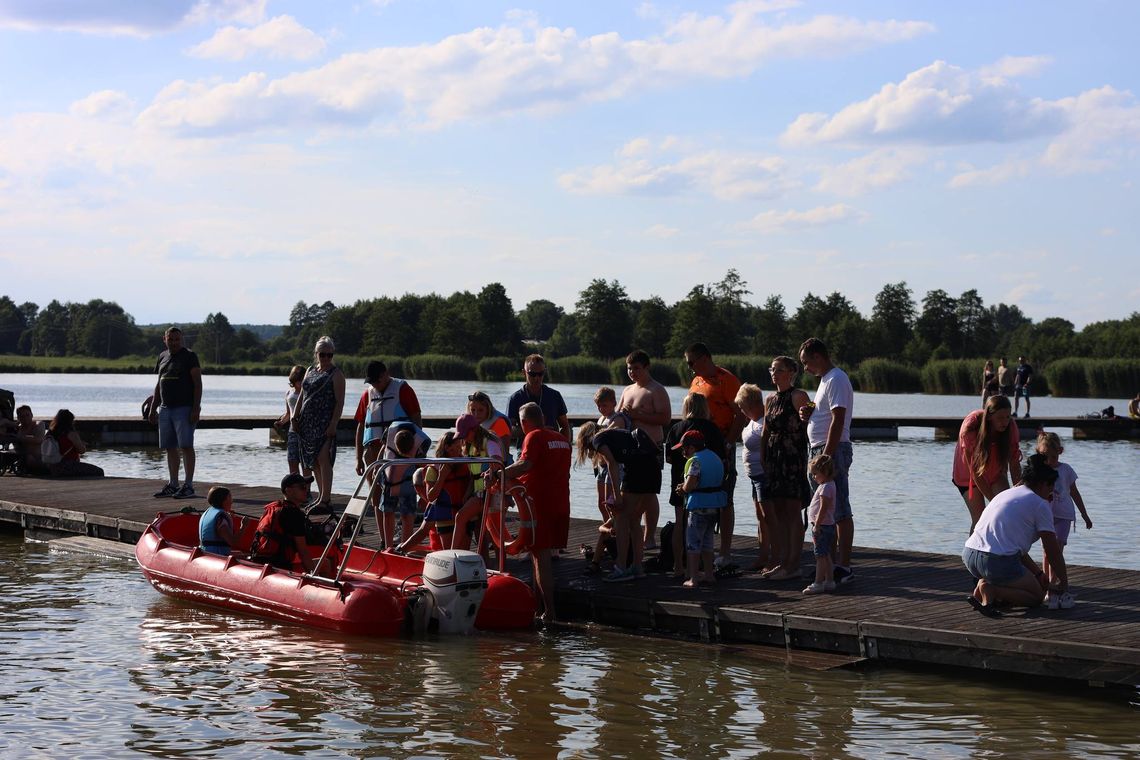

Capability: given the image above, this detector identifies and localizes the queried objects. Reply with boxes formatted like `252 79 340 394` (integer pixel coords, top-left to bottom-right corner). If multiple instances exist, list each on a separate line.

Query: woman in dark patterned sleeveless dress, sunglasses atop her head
291 335 344 510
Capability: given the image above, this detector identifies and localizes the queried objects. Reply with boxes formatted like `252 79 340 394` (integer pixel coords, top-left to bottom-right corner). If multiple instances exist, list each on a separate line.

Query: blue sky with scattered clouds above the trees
0 0 1140 327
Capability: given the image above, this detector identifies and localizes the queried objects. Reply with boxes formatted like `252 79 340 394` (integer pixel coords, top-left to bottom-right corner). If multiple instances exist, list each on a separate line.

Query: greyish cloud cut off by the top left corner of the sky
0 0 266 36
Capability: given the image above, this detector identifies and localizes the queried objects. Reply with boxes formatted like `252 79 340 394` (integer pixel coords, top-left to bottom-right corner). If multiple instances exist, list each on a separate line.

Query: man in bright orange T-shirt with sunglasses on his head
685 343 748 575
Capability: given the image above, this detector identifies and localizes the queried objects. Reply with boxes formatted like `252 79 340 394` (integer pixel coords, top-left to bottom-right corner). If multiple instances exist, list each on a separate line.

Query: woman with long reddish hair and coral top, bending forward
953 395 1021 531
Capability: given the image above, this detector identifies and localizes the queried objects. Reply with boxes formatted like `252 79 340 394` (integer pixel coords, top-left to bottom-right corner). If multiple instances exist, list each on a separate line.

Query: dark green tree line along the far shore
0 269 1140 367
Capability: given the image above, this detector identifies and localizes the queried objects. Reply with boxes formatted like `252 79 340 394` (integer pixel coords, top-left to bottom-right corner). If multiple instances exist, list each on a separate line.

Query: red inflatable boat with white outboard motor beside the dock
135 460 535 636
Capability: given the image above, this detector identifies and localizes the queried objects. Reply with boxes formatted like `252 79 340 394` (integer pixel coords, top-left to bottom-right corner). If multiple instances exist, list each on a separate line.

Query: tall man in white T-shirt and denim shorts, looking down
799 337 855 583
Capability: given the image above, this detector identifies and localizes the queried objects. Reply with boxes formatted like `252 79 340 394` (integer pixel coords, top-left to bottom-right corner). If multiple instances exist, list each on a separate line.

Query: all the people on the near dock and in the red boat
0 327 1112 615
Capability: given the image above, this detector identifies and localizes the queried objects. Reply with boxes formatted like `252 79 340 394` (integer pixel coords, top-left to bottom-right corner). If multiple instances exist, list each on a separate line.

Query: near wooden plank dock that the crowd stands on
0 476 1140 687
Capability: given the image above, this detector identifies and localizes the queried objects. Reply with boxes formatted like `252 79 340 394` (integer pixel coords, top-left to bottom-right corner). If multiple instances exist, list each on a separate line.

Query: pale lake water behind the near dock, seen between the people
0 375 1140 570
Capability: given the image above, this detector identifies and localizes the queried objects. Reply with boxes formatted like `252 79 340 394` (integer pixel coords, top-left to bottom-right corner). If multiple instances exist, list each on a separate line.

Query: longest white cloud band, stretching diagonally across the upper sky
135 3 933 133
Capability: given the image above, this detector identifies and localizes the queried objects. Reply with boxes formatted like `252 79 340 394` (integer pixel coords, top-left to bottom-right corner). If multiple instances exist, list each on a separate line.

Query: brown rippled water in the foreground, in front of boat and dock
0 532 1140 760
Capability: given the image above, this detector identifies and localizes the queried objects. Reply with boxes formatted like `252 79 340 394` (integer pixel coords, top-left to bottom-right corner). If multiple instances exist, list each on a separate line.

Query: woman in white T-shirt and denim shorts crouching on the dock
962 453 1068 615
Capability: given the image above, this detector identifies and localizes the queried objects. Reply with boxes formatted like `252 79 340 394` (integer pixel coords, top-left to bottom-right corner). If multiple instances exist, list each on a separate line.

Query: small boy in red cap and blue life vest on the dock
673 430 728 588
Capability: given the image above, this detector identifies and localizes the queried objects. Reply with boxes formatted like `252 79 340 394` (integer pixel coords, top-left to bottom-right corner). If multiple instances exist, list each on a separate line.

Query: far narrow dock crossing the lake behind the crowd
68 416 1140 446
